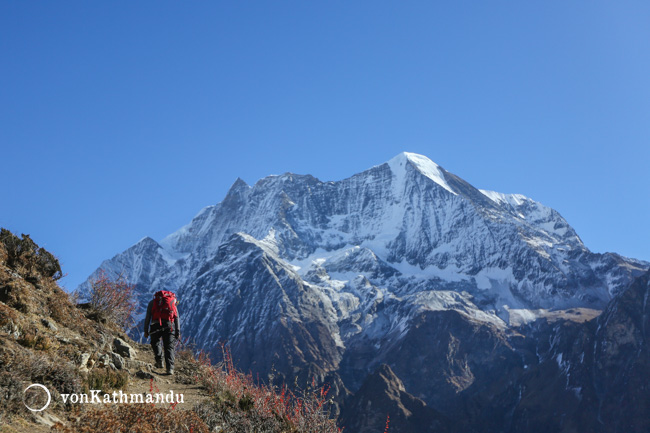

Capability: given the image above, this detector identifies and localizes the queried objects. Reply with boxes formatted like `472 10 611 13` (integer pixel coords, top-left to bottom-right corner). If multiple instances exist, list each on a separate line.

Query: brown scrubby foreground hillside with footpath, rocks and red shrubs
0 229 336 433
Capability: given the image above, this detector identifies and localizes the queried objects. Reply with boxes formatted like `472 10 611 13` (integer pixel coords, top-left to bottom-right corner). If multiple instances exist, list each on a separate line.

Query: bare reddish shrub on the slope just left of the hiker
88 270 136 330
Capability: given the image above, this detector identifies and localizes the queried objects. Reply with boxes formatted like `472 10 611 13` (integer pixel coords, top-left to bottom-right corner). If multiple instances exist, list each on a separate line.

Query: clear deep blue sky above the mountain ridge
0 0 650 289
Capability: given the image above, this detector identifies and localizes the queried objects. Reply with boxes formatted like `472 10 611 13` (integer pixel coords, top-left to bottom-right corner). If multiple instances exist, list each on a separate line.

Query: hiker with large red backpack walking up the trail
144 290 181 374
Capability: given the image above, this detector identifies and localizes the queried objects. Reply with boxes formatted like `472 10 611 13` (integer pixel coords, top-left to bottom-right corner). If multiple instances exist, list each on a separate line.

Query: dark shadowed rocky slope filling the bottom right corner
502 274 650 432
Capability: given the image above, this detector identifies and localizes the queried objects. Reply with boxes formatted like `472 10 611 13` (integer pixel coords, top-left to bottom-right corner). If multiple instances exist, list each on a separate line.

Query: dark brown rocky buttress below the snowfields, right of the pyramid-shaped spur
382 310 522 413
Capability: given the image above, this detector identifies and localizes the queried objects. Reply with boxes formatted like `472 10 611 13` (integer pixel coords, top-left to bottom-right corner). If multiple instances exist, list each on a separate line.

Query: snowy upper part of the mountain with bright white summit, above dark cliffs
85 153 645 321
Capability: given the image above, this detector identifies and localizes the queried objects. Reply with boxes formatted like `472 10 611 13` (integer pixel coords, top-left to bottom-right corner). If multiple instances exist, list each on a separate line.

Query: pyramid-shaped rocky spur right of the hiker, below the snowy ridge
177 235 340 374
